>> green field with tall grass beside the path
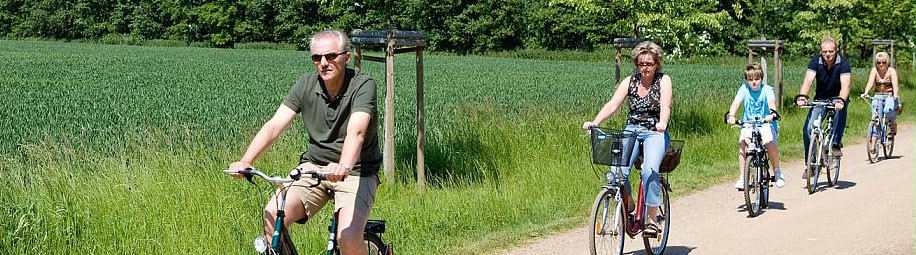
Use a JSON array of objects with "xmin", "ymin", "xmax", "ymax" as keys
[{"xmin": 0, "ymin": 41, "xmax": 916, "ymax": 254}]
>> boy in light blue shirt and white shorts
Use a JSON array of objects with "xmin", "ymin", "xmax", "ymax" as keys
[{"xmin": 727, "ymin": 63, "xmax": 786, "ymax": 189}]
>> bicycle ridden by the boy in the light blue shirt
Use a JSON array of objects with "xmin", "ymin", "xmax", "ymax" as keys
[{"xmin": 725, "ymin": 112, "xmax": 780, "ymax": 217}]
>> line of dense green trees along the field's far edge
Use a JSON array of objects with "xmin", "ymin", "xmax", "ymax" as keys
[{"xmin": 0, "ymin": 0, "xmax": 916, "ymax": 56}]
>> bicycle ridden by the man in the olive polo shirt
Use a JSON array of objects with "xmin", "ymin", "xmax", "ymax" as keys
[{"xmin": 223, "ymin": 168, "xmax": 393, "ymax": 255}]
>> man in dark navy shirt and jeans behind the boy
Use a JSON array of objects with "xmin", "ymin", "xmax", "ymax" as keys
[{"xmin": 795, "ymin": 37, "xmax": 852, "ymax": 177}]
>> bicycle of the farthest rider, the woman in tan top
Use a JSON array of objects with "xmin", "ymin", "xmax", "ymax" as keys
[{"xmin": 861, "ymin": 94, "xmax": 894, "ymax": 163}]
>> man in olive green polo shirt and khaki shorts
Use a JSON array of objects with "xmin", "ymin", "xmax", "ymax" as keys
[{"xmin": 229, "ymin": 30, "xmax": 382, "ymax": 255}]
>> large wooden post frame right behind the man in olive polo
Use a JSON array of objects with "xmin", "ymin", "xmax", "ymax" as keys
[{"xmin": 350, "ymin": 29, "xmax": 426, "ymax": 190}]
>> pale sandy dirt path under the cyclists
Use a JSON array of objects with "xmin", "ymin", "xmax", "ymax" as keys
[{"xmin": 503, "ymin": 124, "xmax": 916, "ymax": 255}]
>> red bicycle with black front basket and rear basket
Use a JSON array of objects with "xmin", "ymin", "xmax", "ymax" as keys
[{"xmin": 588, "ymin": 127, "xmax": 684, "ymax": 255}]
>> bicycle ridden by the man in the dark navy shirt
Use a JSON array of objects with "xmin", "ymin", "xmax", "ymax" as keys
[{"xmin": 800, "ymin": 100, "xmax": 840, "ymax": 194}]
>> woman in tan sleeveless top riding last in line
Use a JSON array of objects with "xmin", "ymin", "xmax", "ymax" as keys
[{"xmin": 859, "ymin": 51, "xmax": 900, "ymax": 135}]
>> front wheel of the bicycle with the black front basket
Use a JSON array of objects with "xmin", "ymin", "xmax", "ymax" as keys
[{"xmin": 588, "ymin": 188, "xmax": 626, "ymax": 255}]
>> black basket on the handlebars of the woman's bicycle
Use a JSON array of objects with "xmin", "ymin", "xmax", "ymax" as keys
[{"xmin": 591, "ymin": 128, "xmax": 636, "ymax": 167}]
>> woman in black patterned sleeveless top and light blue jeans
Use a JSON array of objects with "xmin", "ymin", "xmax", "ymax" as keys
[{"xmin": 582, "ymin": 41, "xmax": 672, "ymax": 234}]
